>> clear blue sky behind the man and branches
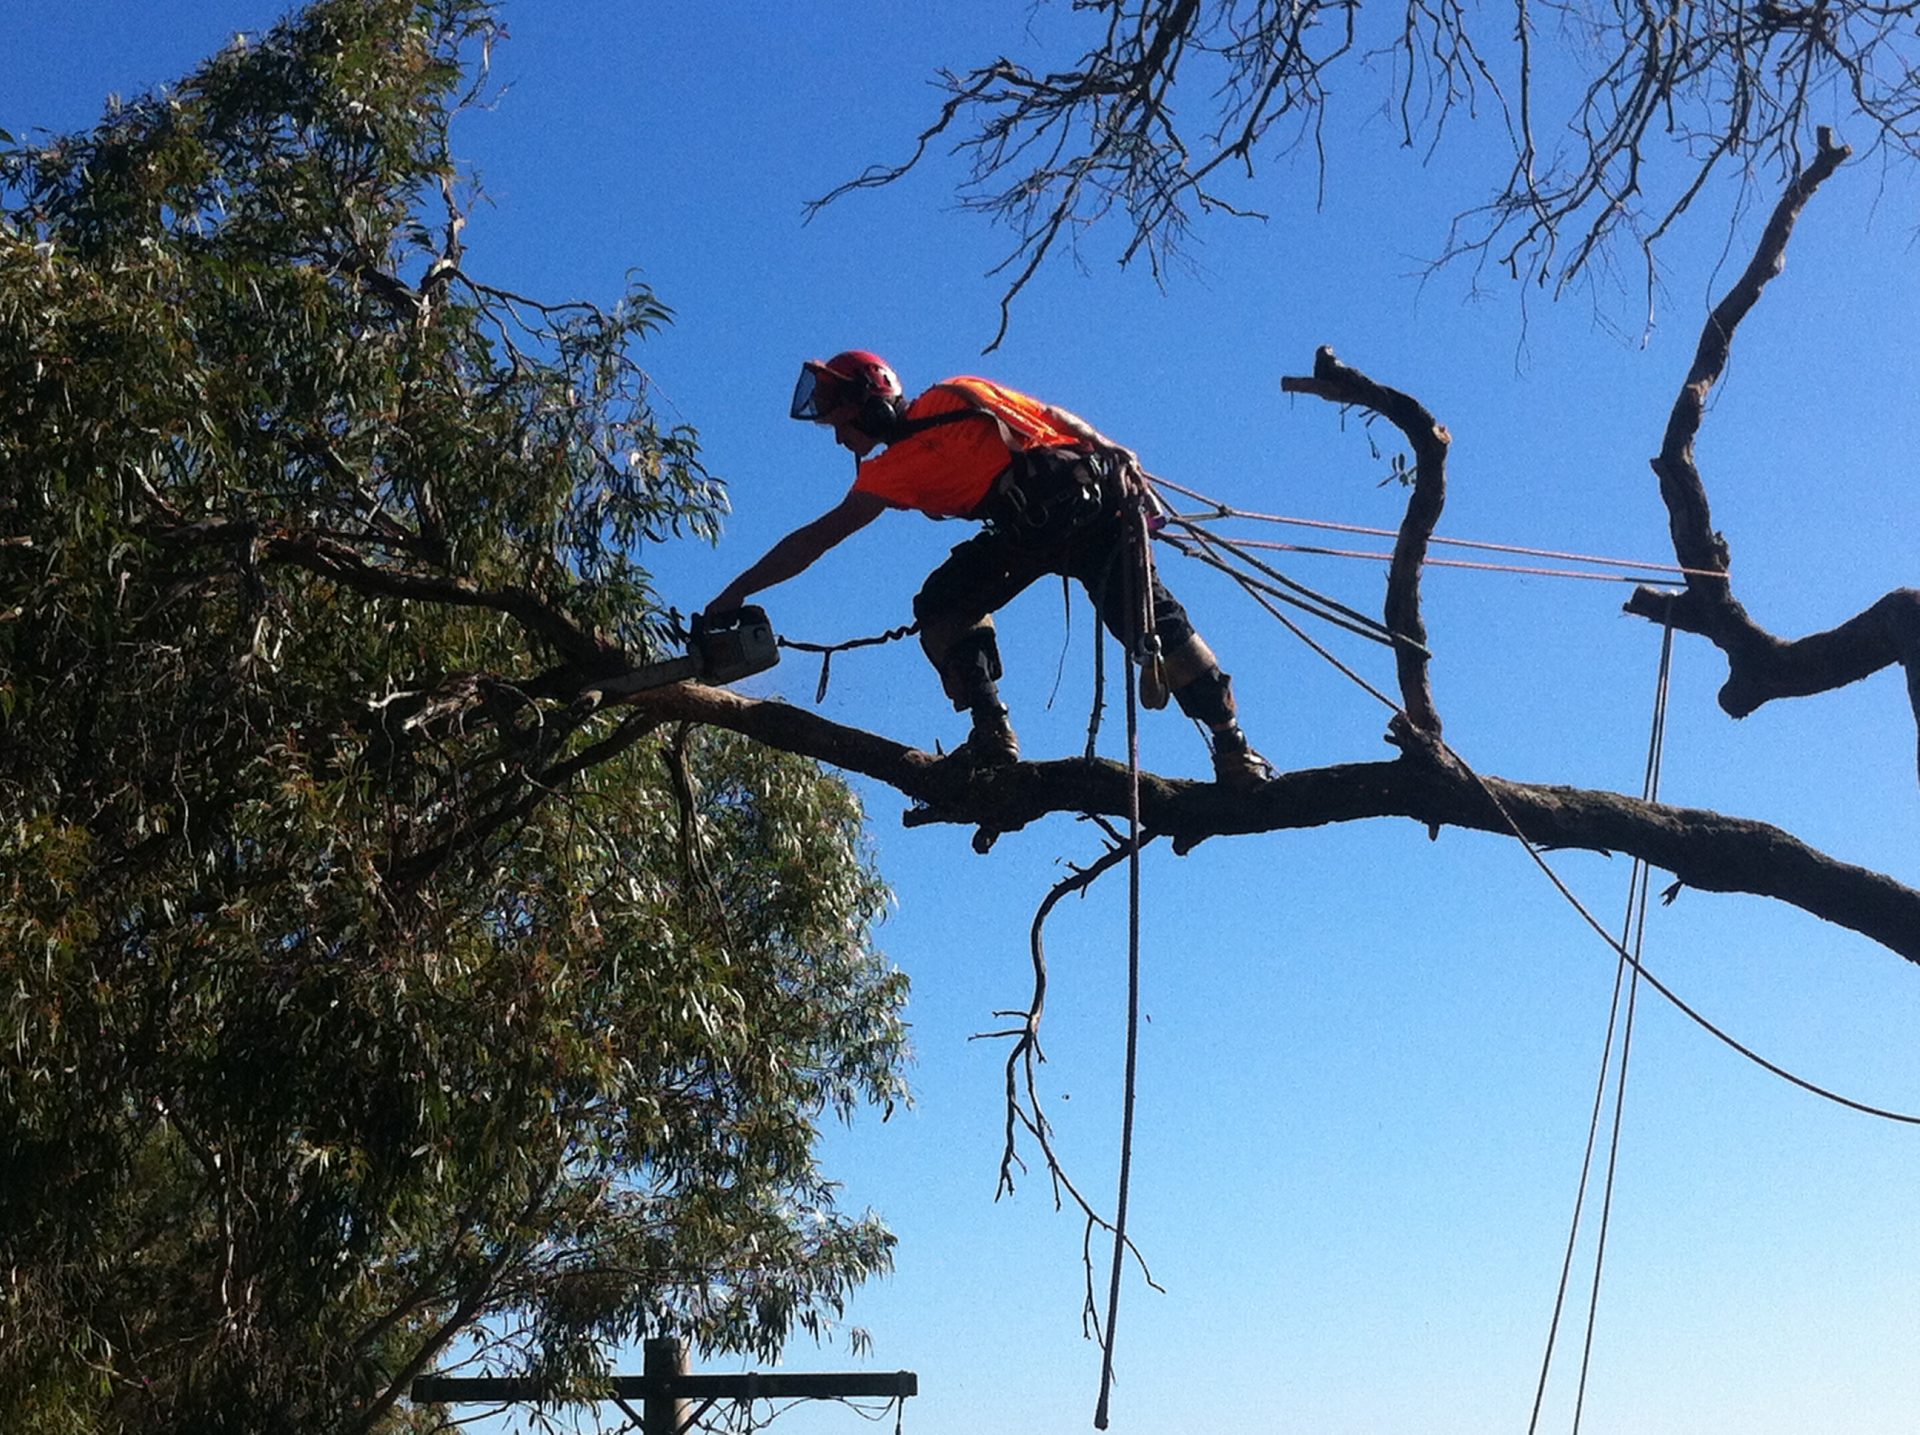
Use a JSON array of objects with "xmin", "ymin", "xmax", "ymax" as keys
[{"xmin": 0, "ymin": 0, "xmax": 1920, "ymax": 1435}]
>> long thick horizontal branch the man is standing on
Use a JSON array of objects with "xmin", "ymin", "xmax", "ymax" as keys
[{"xmin": 634, "ymin": 682, "xmax": 1920, "ymax": 962}]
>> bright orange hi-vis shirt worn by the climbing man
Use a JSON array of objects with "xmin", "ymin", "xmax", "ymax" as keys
[{"xmin": 852, "ymin": 375, "xmax": 1081, "ymax": 519}]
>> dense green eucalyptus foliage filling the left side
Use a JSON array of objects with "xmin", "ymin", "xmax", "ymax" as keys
[{"xmin": 0, "ymin": 0, "xmax": 904, "ymax": 1431}]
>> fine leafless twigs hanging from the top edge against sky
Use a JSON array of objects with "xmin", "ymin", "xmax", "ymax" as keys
[{"xmin": 837, "ymin": 0, "xmax": 1920, "ymax": 338}]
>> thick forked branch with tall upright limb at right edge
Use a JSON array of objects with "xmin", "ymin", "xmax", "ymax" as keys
[{"xmin": 1626, "ymin": 129, "xmax": 1920, "ymax": 779}]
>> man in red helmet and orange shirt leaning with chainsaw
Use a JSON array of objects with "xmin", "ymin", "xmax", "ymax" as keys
[{"xmin": 708, "ymin": 350, "xmax": 1273, "ymax": 790}]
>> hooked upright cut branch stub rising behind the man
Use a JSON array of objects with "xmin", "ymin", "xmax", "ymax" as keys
[{"xmin": 1281, "ymin": 344, "xmax": 1453, "ymax": 738}]
